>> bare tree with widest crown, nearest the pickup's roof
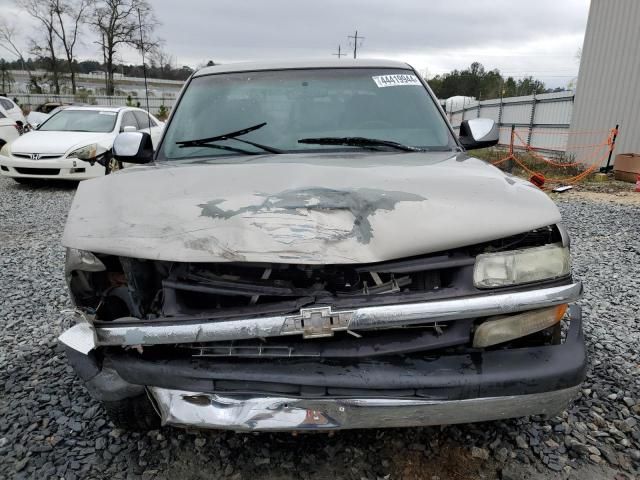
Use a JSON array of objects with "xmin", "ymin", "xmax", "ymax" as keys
[{"xmin": 91, "ymin": 0, "xmax": 158, "ymax": 95}]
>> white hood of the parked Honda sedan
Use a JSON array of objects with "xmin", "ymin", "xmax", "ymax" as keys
[{"xmin": 11, "ymin": 130, "xmax": 113, "ymax": 155}]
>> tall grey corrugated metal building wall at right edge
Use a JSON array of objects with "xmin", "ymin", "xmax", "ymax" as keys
[{"xmin": 571, "ymin": 0, "xmax": 640, "ymax": 163}]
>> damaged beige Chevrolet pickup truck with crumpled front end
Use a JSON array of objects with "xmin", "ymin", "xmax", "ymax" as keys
[{"xmin": 60, "ymin": 60, "xmax": 586, "ymax": 431}]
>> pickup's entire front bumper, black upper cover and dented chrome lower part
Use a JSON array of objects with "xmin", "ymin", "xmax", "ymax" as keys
[{"xmin": 61, "ymin": 305, "xmax": 586, "ymax": 431}]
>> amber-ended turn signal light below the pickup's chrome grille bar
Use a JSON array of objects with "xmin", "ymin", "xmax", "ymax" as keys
[{"xmin": 473, "ymin": 303, "xmax": 567, "ymax": 348}]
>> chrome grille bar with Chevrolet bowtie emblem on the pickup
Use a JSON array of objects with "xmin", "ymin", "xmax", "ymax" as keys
[{"xmin": 91, "ymin": 282, "xmax": 582, "ymax": 351}]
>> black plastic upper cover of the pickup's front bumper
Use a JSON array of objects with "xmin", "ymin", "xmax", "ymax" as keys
[{"xmin": 105, "ymin": 306, "xmax": 586, "ymax": 400}]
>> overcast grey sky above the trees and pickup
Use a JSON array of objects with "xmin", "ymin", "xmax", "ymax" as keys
[{"xmin": 0, "ymin": 0, "xmax": 589, "ymax": 87}]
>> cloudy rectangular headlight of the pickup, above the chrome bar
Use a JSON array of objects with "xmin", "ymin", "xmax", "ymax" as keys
[{"xmin": 473, "ymin": 243, "xmax": 571, "ymax": 288}]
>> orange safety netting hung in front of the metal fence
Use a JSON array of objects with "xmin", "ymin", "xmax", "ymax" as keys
[{"xmin": 492, "ymin": 128, "xmax": 618, "ymax": 183}]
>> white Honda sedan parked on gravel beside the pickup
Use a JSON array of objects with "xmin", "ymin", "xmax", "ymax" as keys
[{"xmin": 0, "ymin": 106, "xmax": 164, "ymax": 183}]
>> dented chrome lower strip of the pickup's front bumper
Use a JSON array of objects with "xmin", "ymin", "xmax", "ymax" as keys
[{"xmin": 149, "ymin": 386, "xmax": 579, "ymax": 431}]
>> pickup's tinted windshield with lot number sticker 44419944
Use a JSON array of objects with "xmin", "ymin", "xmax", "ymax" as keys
[{"xmin": 158, "ymin": 68, "xmax": 455, "ymax": 160}]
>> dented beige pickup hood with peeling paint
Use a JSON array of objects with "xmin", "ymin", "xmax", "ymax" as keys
[{"xmin": 63, "ymin": 152, "xmax": 560, "ymax": 264}]
